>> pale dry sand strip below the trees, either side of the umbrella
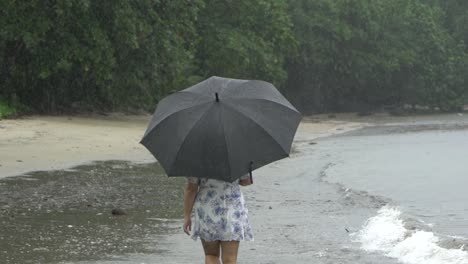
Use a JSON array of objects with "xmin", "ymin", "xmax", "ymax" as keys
[{"xmin": 0, "ymin": 114, "xmax": 361, "ymax": 178}]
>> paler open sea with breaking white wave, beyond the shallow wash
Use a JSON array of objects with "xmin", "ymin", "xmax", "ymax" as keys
[{"xmin": 316, "ymin": 124, "xmax": 468, "ymax": 264}]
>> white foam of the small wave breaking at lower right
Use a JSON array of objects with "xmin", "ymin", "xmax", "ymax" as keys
[{"xmin": 352, "ymin": 206, "xmax": 468, "ymax": 264}]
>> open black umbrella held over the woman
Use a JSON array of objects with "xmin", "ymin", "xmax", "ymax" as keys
[{"xmin": 141, "ymin": 76, "xmax": 301, "ymax": 182}]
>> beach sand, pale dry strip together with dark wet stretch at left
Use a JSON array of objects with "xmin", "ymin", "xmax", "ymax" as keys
[{"xmin": 0, "ymin": 115, "xmax": 361, "ymax": 263}]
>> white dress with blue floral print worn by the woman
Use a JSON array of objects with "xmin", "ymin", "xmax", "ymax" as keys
[{"xmin": 188, "ymin": 177, "xmax": 254, "ymax": 241}]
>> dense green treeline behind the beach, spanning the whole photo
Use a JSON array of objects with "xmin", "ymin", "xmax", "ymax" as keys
[{"xmin": 0, "ymin": 0, "xmax": 468, "ymax": 113}]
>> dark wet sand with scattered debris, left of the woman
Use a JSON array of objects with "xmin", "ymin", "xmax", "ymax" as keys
[{"xmin": 0, "ymin": 161, "xmax": 184, "ymax": 264}]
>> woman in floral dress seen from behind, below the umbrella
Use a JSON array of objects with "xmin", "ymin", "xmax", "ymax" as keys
[{"xmin": 184, "ymin": 175, "xmax": 253, "ymax": 264}]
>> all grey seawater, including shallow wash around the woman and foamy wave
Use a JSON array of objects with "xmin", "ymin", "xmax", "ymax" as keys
[{"xmin": 74, "ymin": 121, "xmax": 468, "ymax": 264}]
